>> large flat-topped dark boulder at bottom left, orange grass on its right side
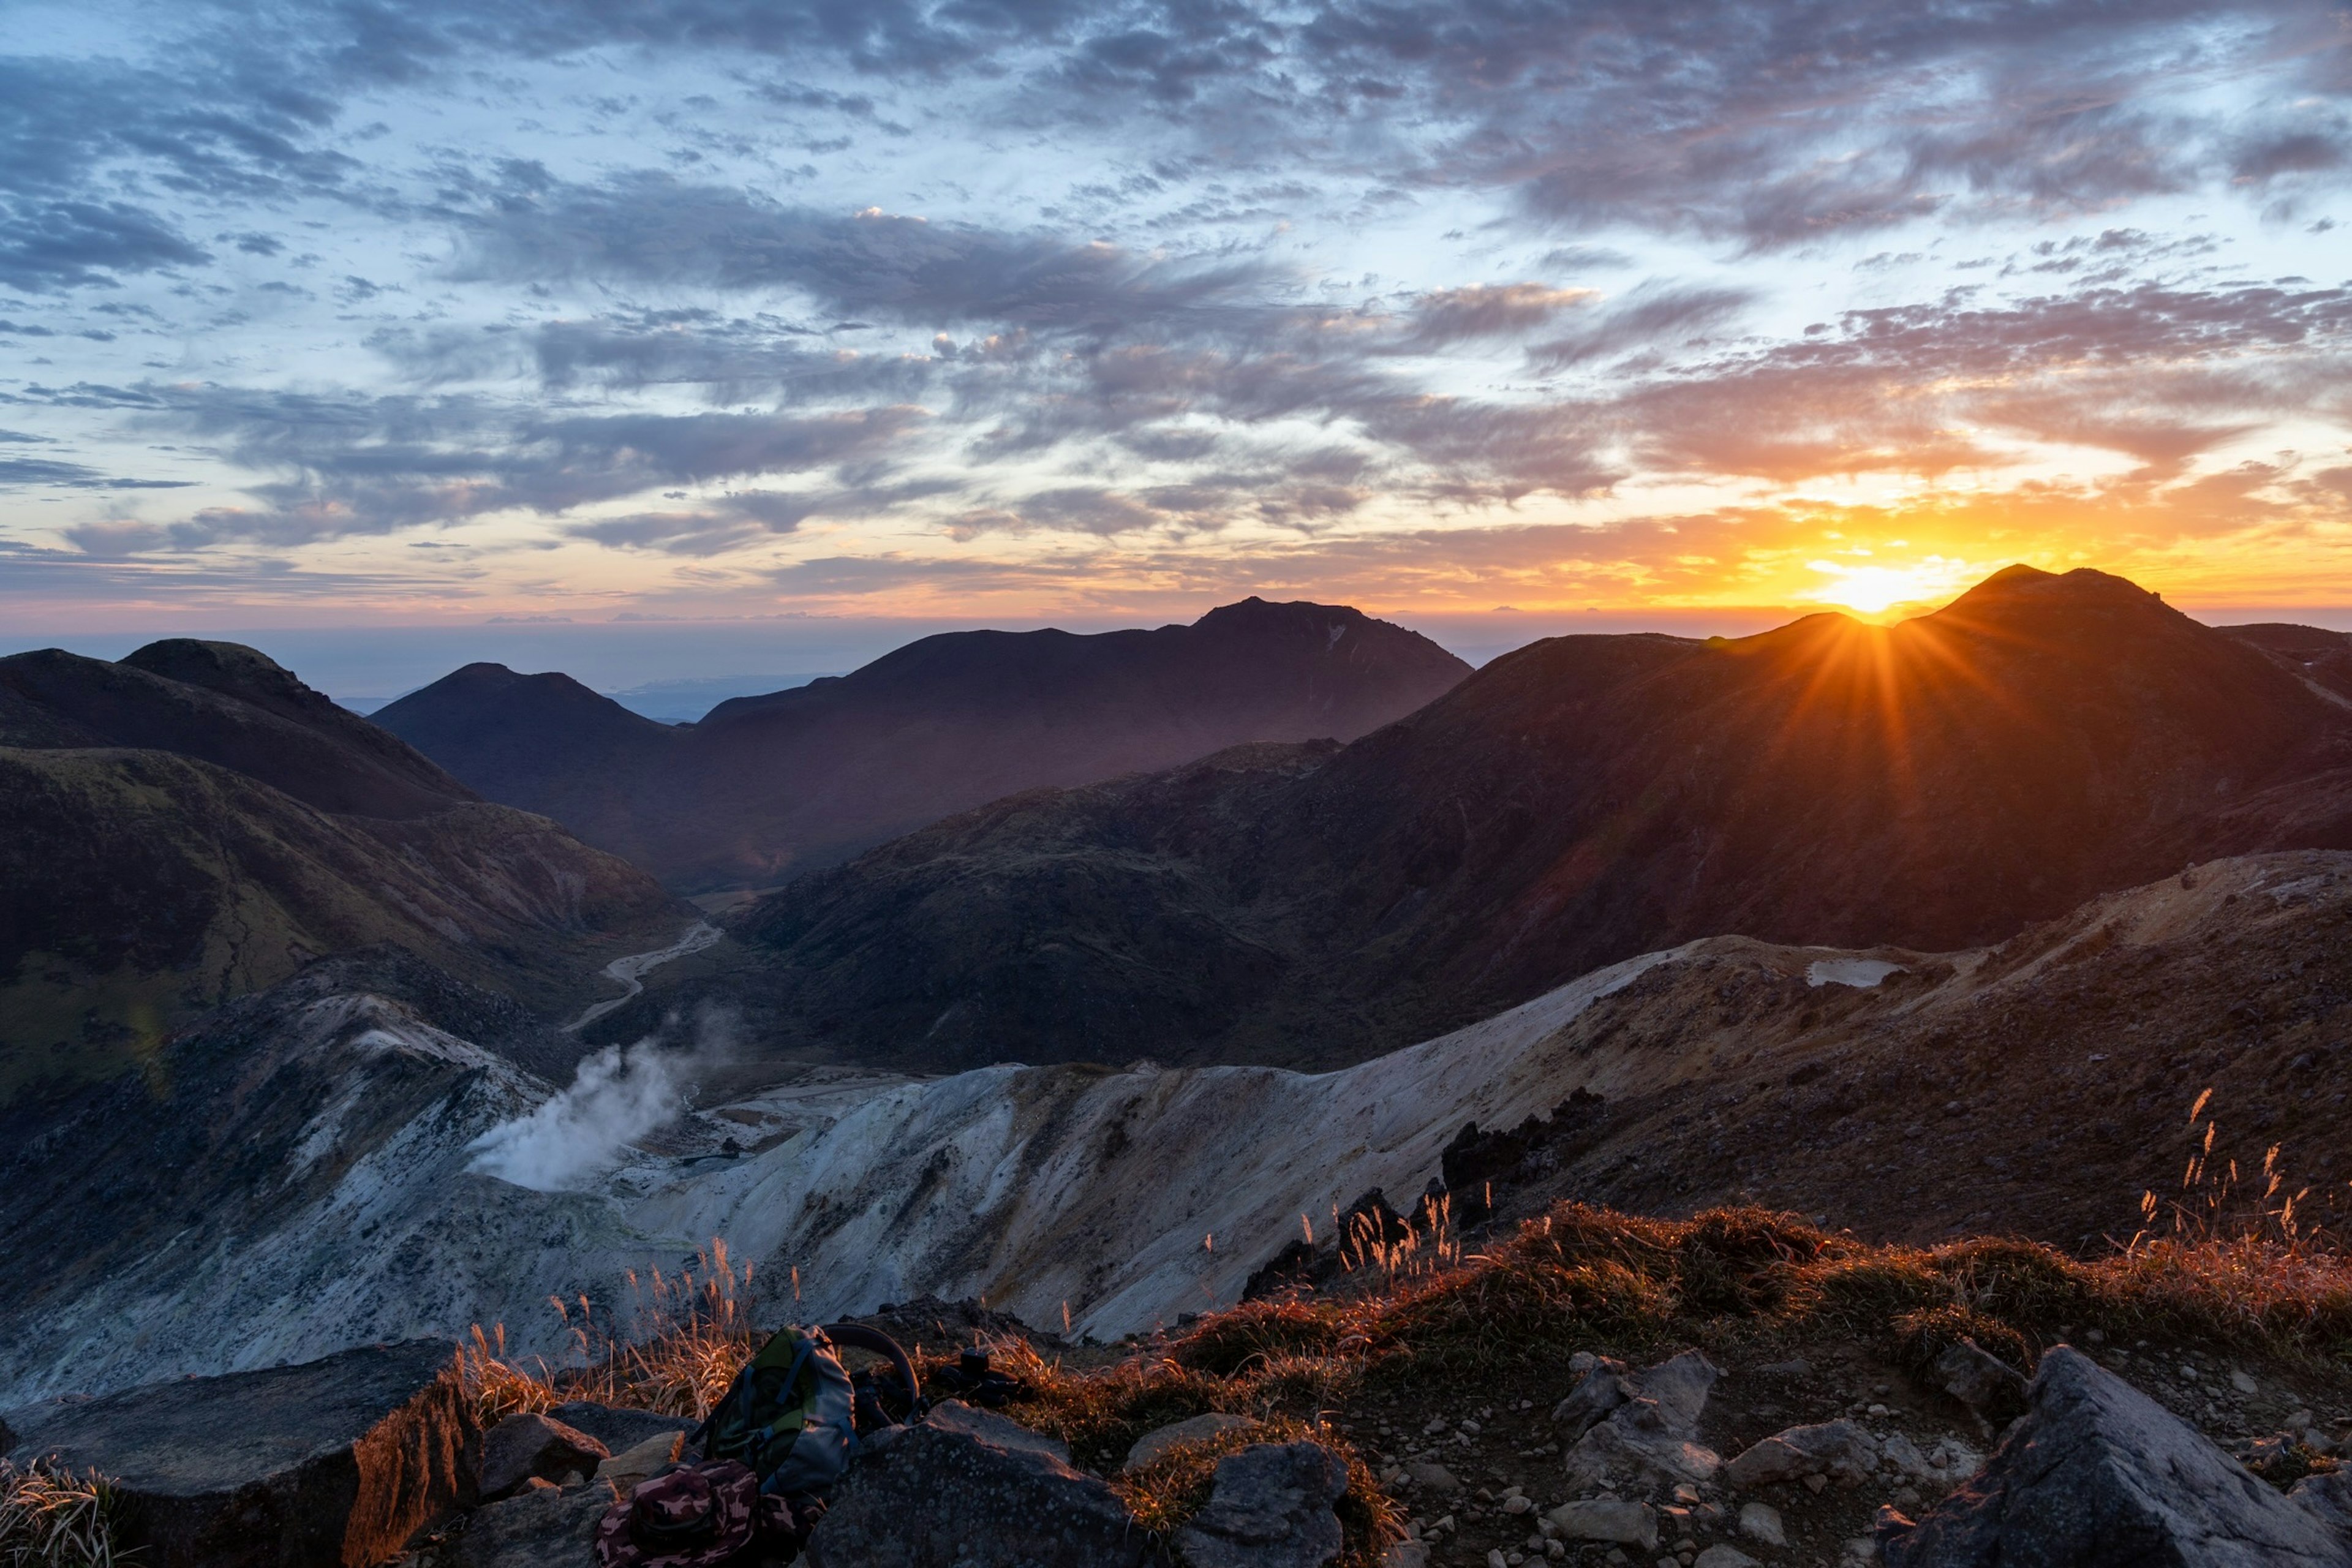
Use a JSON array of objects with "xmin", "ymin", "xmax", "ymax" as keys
[{"xmin": 12, "ymin": 1340, "xmax": 478, "ymax": 1568}]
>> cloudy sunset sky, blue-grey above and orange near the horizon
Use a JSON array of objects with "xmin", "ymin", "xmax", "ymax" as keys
[{"xmin": 0, "ymin": 0, "xmax": 2352, "ymax": 635}]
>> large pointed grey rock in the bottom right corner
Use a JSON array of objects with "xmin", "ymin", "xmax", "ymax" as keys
[{"xmin": 1882, "ymin": 1344, "xmax": 2352, "ymax": 1568}]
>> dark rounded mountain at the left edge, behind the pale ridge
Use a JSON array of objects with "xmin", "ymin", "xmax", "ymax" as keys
[{"xmin": 0, "ymin": 639, "xmax": 684, "ymax": 1098}]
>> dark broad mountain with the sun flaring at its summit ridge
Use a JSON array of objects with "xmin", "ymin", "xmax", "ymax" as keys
[{"xmin": 649, "ymin": 567, "xmax": 2352, "ymax": 1069}]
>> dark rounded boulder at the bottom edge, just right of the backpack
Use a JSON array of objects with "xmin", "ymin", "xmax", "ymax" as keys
[{"xmin": 807, "ymin": 1399, "xmax": 1150, "ymax": 1568}]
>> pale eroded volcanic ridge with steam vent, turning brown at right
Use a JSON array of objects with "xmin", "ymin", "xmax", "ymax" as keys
[{"xmin": 0, "ymin": 853, "xmax": 2352, "ymax": 1411}]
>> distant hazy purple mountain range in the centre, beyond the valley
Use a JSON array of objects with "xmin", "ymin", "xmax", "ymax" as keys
[{"xmin": 374, "ymin": 600, "xmax": 1470, "ymax": 891}]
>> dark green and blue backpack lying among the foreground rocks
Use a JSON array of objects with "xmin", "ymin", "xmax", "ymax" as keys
[{"xmin": 689, "ymin": 1324, "xmax": 919, "ymax": 1498}]
